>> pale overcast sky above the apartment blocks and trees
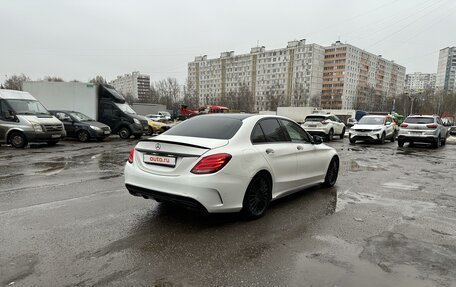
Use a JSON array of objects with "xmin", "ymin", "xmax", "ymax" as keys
[{"xmin": 0, "ymin": 0, "xmax": 456, "ymax": 84}]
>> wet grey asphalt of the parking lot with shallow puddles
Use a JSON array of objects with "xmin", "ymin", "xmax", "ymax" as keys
[{"xmin": 0, "ymin": 138, "xmax": 456, "ymax": 286}]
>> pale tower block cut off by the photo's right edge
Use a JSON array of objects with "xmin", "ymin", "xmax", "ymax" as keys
[{"xmin": 435, "ymin": 47, "xmax": 456, "ymax": 92}]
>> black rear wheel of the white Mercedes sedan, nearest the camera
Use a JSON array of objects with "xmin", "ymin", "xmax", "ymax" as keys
[{"xmin": 242, "ymin": 174, "xmax": 272, "ymax": 219}]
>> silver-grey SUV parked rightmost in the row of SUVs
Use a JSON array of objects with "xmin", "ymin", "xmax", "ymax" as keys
[{"xmin": 397, "ymin": 115, "xmax": 448, "ymax": 148}]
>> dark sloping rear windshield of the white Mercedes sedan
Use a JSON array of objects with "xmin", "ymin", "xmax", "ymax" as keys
[{"xmin": 164, "ymin": 116, "xmax": 242, "ymax": 140}]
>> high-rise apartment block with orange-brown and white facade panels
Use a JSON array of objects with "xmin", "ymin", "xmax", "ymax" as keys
[{"xmin": 321, "ymin": 41, "xmax": 405, "ymax": 109}]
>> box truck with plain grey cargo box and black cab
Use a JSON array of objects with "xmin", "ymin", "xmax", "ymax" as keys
[{"xmin": 23, "ymin": 81, "xmax": 149, "ymax": 139}]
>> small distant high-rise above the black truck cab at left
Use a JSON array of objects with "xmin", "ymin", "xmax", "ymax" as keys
[{"xmin": 109, "ymin": 72, "xmax": 150, "ymax": 100}]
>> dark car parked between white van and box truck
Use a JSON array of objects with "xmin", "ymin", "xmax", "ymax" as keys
[{"xmin": 49, "ymin": 110, "xmax": 111, "ymax": 142}]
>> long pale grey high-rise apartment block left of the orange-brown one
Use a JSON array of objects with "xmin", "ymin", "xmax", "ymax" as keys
[{"xmin": 188, "ymin": 40, "xmax": 325, "ymax": 111}]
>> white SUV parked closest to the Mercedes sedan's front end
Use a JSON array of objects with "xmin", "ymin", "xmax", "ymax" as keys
[{"xmin": 302, "ymin": 114, "xmax": 345, "ymax": 141}]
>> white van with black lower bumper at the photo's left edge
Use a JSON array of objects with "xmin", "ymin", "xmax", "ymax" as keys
[{"xmin": 0, "ymin": 89, "xmax": 66, "ymax": 148}]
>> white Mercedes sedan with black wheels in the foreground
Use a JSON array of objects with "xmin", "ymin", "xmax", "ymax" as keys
[{"xmin": 125, "ymin": 114, "xmax": 339, "ymax": 218}]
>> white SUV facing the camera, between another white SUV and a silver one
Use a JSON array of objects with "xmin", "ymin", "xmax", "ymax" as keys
[{"xmin": 348, "ymin": 115, "xmax": 397, "ymax": 144}]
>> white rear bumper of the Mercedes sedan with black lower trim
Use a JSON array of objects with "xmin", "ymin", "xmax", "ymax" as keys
[{"xmin": 125, "ymin": 162, "xmax": 250, "ymax": 213}]
